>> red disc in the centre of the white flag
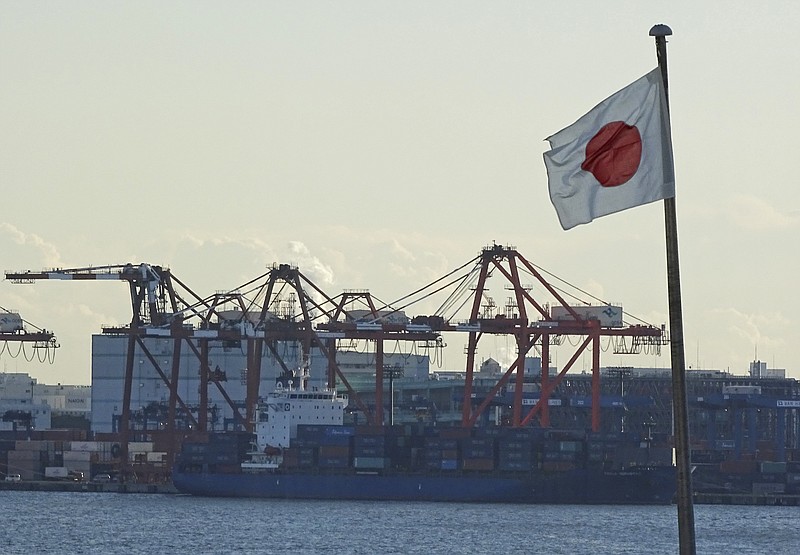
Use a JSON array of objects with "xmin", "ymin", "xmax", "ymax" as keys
[{"xmin": 581, "ymin": 121, "xmax": 642, "ymax": 187}]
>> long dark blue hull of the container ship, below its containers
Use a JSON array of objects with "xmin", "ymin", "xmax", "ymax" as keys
[{"xmin": 173, "ymin": 467, "xmax": 675, "ymax": 504}]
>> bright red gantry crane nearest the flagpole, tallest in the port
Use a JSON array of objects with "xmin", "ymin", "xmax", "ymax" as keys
[{"xmin": 340, "ymin": 245, "xmax": 668, "ymax": 431}]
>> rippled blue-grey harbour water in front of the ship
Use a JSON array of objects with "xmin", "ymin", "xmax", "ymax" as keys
[{"xmin": 0, "ymin": 492, "xmax": 800, "ymax": 555}]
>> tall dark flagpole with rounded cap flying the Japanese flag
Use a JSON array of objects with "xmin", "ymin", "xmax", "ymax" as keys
[{"xmin": 650, "ymin": 25, "xmax": 696, "ymax": 555}]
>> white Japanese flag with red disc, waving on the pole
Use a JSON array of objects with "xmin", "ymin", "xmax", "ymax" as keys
[{"xmin": 544, "ymin": 68, "xmax": 675, "ymax": 229}]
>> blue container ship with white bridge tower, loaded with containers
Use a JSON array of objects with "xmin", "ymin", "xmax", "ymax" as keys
[{"xmin": 172, "ymin": 387, "xmax": 676, "ymax": 504}]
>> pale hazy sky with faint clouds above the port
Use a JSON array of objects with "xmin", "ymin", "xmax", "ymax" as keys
[{"xmin": 0, "ymin": 0, "xmax": 800, "ymax": 384}]
